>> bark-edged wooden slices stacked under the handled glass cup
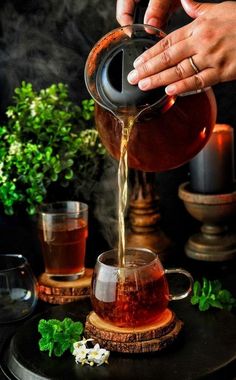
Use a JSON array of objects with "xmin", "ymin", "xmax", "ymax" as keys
[{"xmin": 85, "ymin": 309, "xmax": 183, "ymax": 353}]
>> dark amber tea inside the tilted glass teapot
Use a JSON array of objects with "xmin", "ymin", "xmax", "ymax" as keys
[{"xmin": 95, "ymin": 89, "xmax": 216, "ymax": 172}]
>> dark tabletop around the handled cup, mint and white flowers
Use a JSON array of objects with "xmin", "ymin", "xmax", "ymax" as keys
[{"xmin": 0, "ymin": 259, "xmax": 236, "ymax": 380}]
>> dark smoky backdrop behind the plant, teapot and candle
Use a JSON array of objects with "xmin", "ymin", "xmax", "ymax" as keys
[{"xmin": 0, "ymin": 0, "xmax": 236, "ymax": 271}]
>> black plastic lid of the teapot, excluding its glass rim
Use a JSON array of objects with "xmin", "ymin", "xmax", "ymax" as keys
[{"xmin": 96, "ymin": 31, "xmax": 165, "ymax": 108}]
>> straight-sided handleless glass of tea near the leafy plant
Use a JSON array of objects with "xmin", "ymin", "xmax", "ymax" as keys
[{"xmin": 39, "ymin": 201, "xmax": 88, "ymax": 279}]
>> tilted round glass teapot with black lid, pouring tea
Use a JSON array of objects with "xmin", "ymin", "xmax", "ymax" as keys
[{"xmin": 85, "ymin": 2, "xmax": 216, "ymax": 172}]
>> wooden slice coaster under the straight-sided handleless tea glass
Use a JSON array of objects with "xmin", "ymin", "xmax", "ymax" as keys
[{"xmin": 38, "ymin": 268, "xmax": 93, "ymax": 304}]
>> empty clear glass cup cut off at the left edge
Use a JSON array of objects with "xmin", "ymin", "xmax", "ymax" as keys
[{"xmin": 0, "ymin": 254, "xmax": 38, "ymax": 323}]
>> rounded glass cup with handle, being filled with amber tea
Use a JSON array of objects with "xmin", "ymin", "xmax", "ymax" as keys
[{"xmin": 91, "ymin": 248, "xmax": 193, "ymax": 328}]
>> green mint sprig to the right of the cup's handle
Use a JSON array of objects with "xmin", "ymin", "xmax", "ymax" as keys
[{"xmin": 191, "ymin": 277, "xmax": 236, "ymax": 311}]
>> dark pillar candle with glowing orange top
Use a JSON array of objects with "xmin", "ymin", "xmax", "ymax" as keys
[{"xmin": 190, "ymin": 124, "xmax": 234, "ymax": 194}]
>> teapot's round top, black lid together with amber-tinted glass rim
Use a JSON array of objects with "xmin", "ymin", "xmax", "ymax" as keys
[{"xmin": 85, "ymin": 24, "xmax": 166, "ymax": 111}]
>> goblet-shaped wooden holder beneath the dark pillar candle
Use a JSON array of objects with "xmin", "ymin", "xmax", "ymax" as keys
[{"xmin": 179, "ymin": 182, "xmax": 236, "ymax": 262}]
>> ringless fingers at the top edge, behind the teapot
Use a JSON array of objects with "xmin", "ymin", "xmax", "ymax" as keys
[{"xmin": 116, "ymin": 0, "xmax": 180, "ymax": 28}]
